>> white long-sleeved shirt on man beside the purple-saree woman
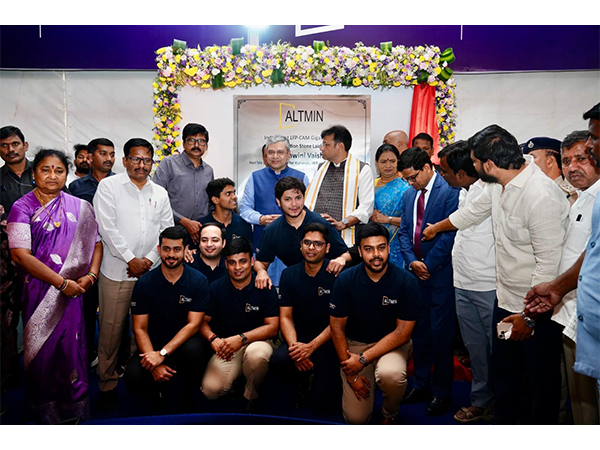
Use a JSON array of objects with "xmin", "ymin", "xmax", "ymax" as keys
[{"xmin": 94, "ymin": 173, "xmax": 173, "ymax": 281}]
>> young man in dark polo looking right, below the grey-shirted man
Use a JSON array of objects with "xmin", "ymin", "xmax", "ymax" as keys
[{"xmin": 200, "ymin": 178, "xmax": 252, "ymax": 246}]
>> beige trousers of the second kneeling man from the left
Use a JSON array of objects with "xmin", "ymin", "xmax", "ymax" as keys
[{"xmin": 201, "ymin": 341, "xmax": 273, "ymax": 400}]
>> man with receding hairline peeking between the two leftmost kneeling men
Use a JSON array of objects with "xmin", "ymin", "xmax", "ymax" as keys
[{"xmin": 190, "ymin": 222, "xmax": 227, "ymax": 284}]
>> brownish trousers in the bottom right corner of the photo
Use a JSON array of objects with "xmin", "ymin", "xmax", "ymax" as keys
[{"xmin": 563, "ymin": 336, "xmax": 598, "ymax": 425}]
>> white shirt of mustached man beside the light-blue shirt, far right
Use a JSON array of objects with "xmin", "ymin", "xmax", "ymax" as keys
[{"xmin": 552, "ymin": 176, "xmax": 600, "ymax": 341}]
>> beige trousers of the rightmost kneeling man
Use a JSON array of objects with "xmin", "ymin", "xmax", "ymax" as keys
[{"xmin": 340, "ymin": 339, "xmax": 412, "ymax": 425}]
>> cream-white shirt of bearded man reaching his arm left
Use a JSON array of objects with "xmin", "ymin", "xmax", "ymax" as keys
[{"xmin": 449, "ymin": 155, "xmax": 569, "ymax": 313}]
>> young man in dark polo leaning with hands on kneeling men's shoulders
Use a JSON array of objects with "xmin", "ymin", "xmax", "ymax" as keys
[{"xmin": 254, "ymin": 177, "xmax": 351, "ymax": 289}]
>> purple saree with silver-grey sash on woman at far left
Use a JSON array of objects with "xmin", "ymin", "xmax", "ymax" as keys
[{"xmin": 7, "ymin": 192, "xmax": 98, "ymax": 424}]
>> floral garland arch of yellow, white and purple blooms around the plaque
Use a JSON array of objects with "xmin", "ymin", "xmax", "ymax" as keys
[{"xmin": 152, "ymin": 38, "xmax": 456, "ymax": 161}]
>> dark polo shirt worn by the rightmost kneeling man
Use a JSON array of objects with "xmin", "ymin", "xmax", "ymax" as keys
[{"xmin": 329, "ymin": 263, "xmax": 419, "ymax": 344}]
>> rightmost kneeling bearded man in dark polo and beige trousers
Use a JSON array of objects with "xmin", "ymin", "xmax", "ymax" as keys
[{"xmin": 330, "ymin": 222, "xmax": 419, "ymax": 424}]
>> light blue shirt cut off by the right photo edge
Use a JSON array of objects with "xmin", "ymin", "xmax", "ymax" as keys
[{"xmin": 575, "ymin": 195, "xmax": 600, "ymax": 379}]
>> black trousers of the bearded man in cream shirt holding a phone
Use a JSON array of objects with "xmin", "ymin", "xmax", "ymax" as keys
[{"xmin": 492, "ymin": 306, "xmax": 562, "ymax": 425}]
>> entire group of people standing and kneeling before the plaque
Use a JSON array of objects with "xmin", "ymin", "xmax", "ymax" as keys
[{"xmin": 0, "ymin": 104, "xmax": 600, "ymax": 424}]
